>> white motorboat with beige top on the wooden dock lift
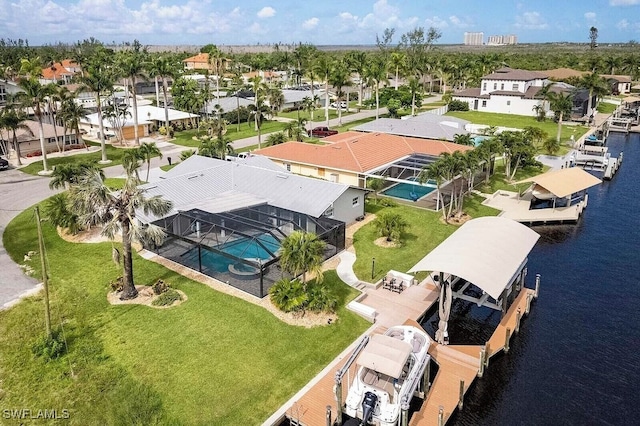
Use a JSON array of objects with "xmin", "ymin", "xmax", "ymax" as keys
[{"xmin": 345, "ymin": 325, "xmax": 431, "ymax": 426}]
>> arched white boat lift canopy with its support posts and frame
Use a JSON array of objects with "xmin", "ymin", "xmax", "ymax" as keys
[{"xmin": 408, "ymin": 217, "xmax": 540, "ymax": 343}]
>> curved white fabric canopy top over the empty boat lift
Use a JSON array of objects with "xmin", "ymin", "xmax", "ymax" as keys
[{"xmin": 408, "ymin": 217, "xmax": 540, "ymax": 300}]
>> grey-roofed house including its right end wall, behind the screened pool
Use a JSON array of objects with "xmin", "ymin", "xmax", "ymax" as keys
[{"xmin": 143, "ymin": 155, "xmax": 367, "ymax": 223}]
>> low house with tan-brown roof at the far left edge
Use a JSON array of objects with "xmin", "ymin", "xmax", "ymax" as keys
[{"xmin": 0, "ymin": 120, "xmax": 76, "ymax": 157}]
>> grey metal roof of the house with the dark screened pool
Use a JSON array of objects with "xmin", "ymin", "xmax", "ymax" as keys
[{"xmin": 143, "ymin": 155, "xmax": 350, "ymax": 217}]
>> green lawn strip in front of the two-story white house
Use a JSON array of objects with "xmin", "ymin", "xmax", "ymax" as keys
[{"xmin": 447, "ymin": 111, "xmax": 589, "ymax": 143}]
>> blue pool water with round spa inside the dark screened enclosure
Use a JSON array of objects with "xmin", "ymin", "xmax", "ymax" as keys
[{"xmin": 183, "ymin": 234, "xmax": 280, "ymax": 272}]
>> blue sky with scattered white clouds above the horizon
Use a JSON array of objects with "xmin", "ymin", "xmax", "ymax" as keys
[{"xmin": 0, "ymin": 0, "xmax": 640, "ymax": 45}]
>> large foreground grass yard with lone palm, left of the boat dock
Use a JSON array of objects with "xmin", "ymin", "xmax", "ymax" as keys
[{"xmin": 0, "ymin": 202, "xmax": 370, "ymax": 425}]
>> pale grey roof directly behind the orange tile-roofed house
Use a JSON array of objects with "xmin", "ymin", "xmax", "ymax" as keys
[{"xmin": 351, "ymin": 113, "xmax": 470, "ymax": 141}]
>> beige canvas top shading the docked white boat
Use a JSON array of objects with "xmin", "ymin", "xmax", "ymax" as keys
[{"xmin": 357, "ymin": 334, "xmax": 411, "ymax": 378}]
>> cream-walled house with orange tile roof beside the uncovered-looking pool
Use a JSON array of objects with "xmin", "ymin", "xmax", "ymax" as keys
[{"xmin": 253, "ymin": 132, "xmax": 473, "ymax": 188}]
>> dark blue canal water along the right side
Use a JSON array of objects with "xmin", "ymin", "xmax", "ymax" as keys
[{"xmin": 444, "ymin": 133, "xmax": 640, "ymax": 426}]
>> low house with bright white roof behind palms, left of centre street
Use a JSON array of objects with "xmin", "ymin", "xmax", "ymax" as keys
[{"xmin": 80, "ymin": 105, "xmax": 199, "ymax": 139}]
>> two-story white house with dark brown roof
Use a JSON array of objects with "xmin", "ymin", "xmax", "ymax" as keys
[{"xmin": 453, "ymin": 68, "xmax": 551, "ymax": 116}]
